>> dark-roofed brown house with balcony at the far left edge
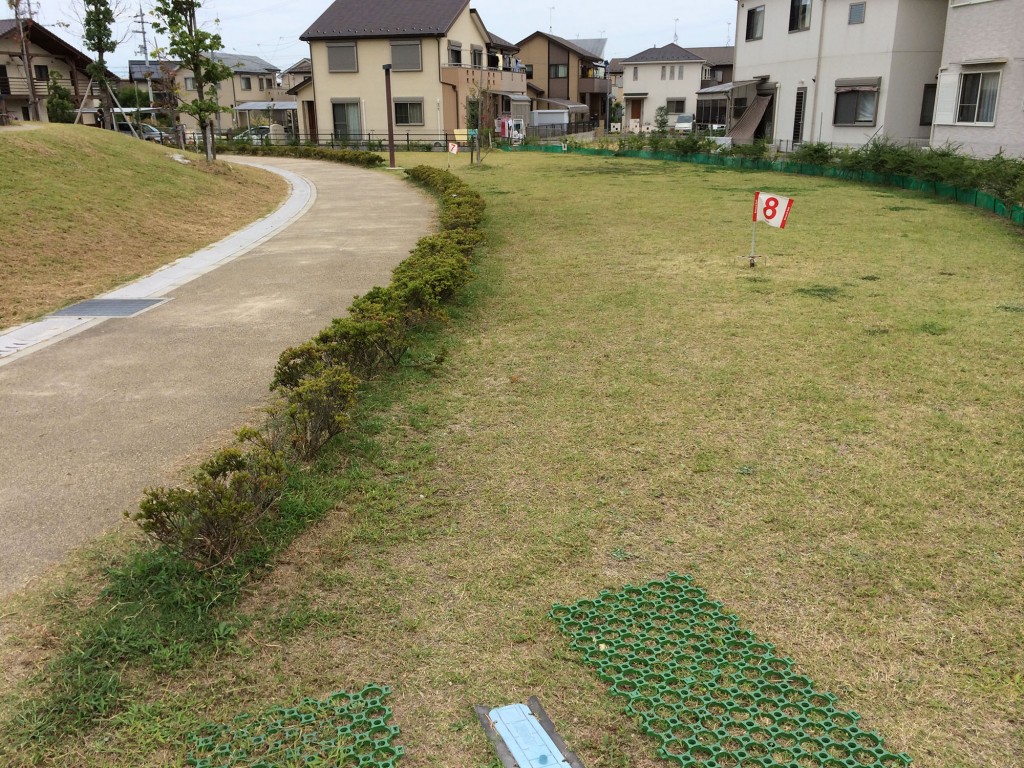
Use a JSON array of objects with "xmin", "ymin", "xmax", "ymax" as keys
[{"xmin": 0, "ymin": 18, "xmax": 112, "ymax": 125}]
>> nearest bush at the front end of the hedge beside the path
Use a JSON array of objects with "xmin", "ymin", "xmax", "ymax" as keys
[{"xmin": 126, "ymin": 447, "xmax": 287, "ymax": 569}]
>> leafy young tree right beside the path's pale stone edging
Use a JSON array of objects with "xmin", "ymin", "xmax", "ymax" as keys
[{"xmin": 153, "ymin": 0, "xmax": 232, "ymax": 162}]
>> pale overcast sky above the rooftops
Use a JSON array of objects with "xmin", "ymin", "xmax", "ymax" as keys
[{"xmin": 32, "ymin": 0, "xmax": 736, "ymax": 77}]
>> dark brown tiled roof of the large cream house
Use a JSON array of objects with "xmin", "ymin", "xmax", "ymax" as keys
[{"xmin": 299, "ymin": 0, "xmax": 469, "ymax": 40}]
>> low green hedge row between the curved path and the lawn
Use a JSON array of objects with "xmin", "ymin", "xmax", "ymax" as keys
[{"xmin": 130, "ymin": 163, "xmax": 484, "ymax": 570}]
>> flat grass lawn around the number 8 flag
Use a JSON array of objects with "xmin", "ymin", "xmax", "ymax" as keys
[{"xmin": 0, "ymin": 147, "xmax": 1024, "ymax": 768}]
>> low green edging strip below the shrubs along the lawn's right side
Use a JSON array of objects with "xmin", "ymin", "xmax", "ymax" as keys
[{"xmin": 505, "ymin": 144, "xmax": 1024, "ymax": 225}]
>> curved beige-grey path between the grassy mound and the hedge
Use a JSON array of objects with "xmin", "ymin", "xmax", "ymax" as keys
[{"xmin": 0, "ymin": 159, "xmax": 435, "ymax": 596}]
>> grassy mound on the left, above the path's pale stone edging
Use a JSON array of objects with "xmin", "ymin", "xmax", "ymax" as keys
[{"xmin": 0, "ymin": 125, "xmax": 286, "ymax": 329}]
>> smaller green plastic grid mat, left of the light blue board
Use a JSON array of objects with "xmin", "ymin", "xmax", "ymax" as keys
[{"xmin": 185, "ymin": 685, "xmax": 406, "ymax": 768}]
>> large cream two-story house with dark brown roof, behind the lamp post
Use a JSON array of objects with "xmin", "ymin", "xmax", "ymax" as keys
[{"xmin": 292, "ymin": 0, "xmax": 526, "ymax": 141}]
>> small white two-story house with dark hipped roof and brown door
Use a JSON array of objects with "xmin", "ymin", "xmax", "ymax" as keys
[{"xmin": 623, "ymin": 43, "xmax": 707, "ymax": 133}]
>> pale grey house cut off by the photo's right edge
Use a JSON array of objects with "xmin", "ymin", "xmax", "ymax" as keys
[{"xmin": 932, "ymin": 0, "xmax": 1024, "ymax": 157}]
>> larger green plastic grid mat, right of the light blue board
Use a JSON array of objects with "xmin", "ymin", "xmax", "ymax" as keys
[{"xmin": 550, "ymin": 573, "xmax": 910, "ymax": 768}]
